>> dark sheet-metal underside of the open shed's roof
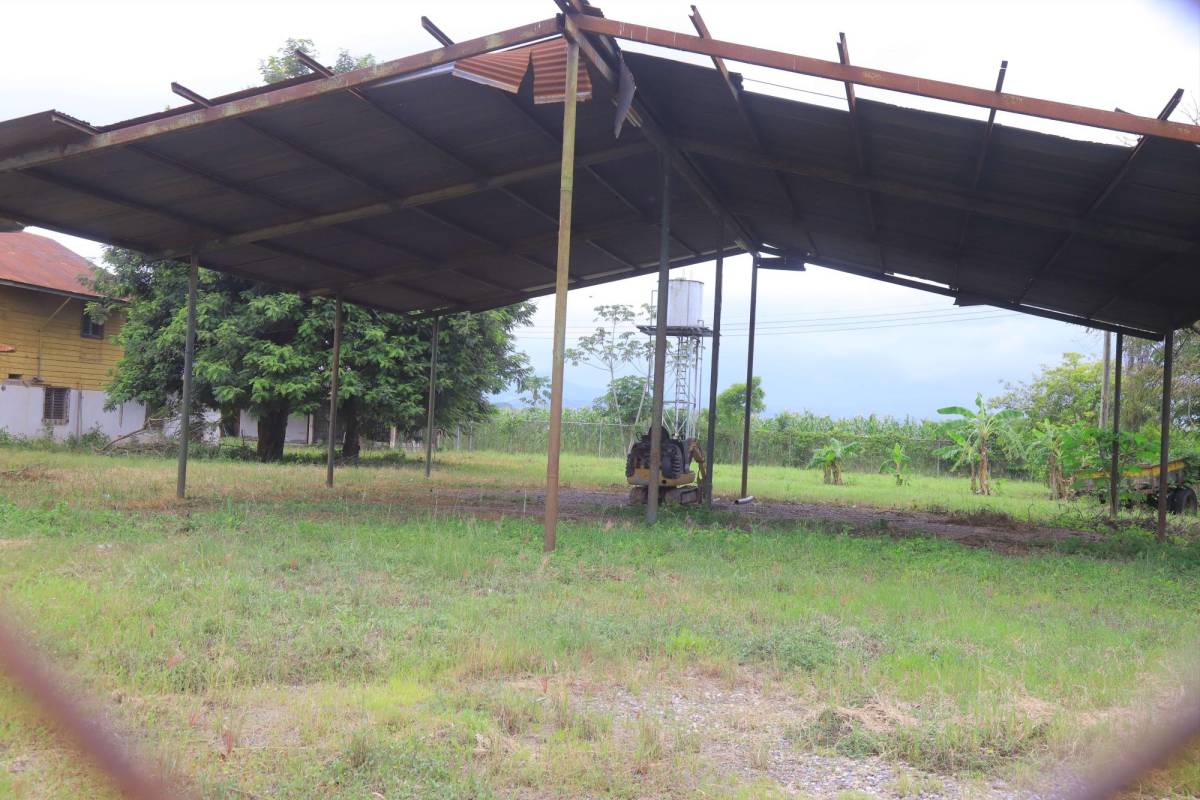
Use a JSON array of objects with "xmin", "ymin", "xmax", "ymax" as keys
[{"xmin": 0, "ymin": 38, "xmax": 1200, "ymax": 337}]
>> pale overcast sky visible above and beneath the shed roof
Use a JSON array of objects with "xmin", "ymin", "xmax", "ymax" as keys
[{"xmin": 0, "ymin": 0, "xmax": 1200, "ymax": 416}]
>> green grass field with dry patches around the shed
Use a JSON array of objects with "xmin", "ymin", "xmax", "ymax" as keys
[{"xmin": 0, "ymin": 449, "xmax": 1200, "ymax": 800}]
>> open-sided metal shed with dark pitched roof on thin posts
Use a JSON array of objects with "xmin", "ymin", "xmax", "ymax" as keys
[{"xmin": 0, "ymin": 0, "xmax": 1200, "ymax": 547}]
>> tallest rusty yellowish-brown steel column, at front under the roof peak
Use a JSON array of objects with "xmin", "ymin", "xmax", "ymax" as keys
[{"xmin": 542, "ymin": 41, "xmax": 580, "ymax": 553}]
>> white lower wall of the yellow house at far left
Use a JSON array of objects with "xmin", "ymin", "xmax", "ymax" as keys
[{"xmin": 0, "ymin": 380, "xmax": 146, "ymax": 441}]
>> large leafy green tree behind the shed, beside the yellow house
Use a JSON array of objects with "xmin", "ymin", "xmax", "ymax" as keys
[{"xmin": 88, "ymin": 40, "xmax": 532, "ymax": 461}]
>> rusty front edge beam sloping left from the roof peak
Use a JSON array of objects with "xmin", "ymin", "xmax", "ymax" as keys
[{"xmin": 0, "ymin": 18, "xmax": 562, "ymax": 173}]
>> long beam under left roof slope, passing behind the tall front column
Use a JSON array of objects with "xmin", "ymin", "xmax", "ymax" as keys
[{"xmin": 157, "ymin": 143, "xmax": 653, "ymax": 259}]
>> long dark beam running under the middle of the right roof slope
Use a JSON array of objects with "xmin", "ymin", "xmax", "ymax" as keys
[{"xmin": 679, "ymin": 139, "xmax": 1200, "ymax": 253}]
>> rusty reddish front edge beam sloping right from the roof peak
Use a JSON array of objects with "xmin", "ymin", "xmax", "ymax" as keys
[{"xmin": 566, "ymin": 14, "xmax": 1200, "ymax": 144}]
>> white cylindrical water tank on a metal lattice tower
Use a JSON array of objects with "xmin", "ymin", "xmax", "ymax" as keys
[{"xmin": 637, "ymin": 278, "xmax": 713, "ymax": 439}]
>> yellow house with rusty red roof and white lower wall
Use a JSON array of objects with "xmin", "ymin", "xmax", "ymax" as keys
[{"xmin": 0, "ymin": 231, "xmax": 145, "ymax": 439}]
